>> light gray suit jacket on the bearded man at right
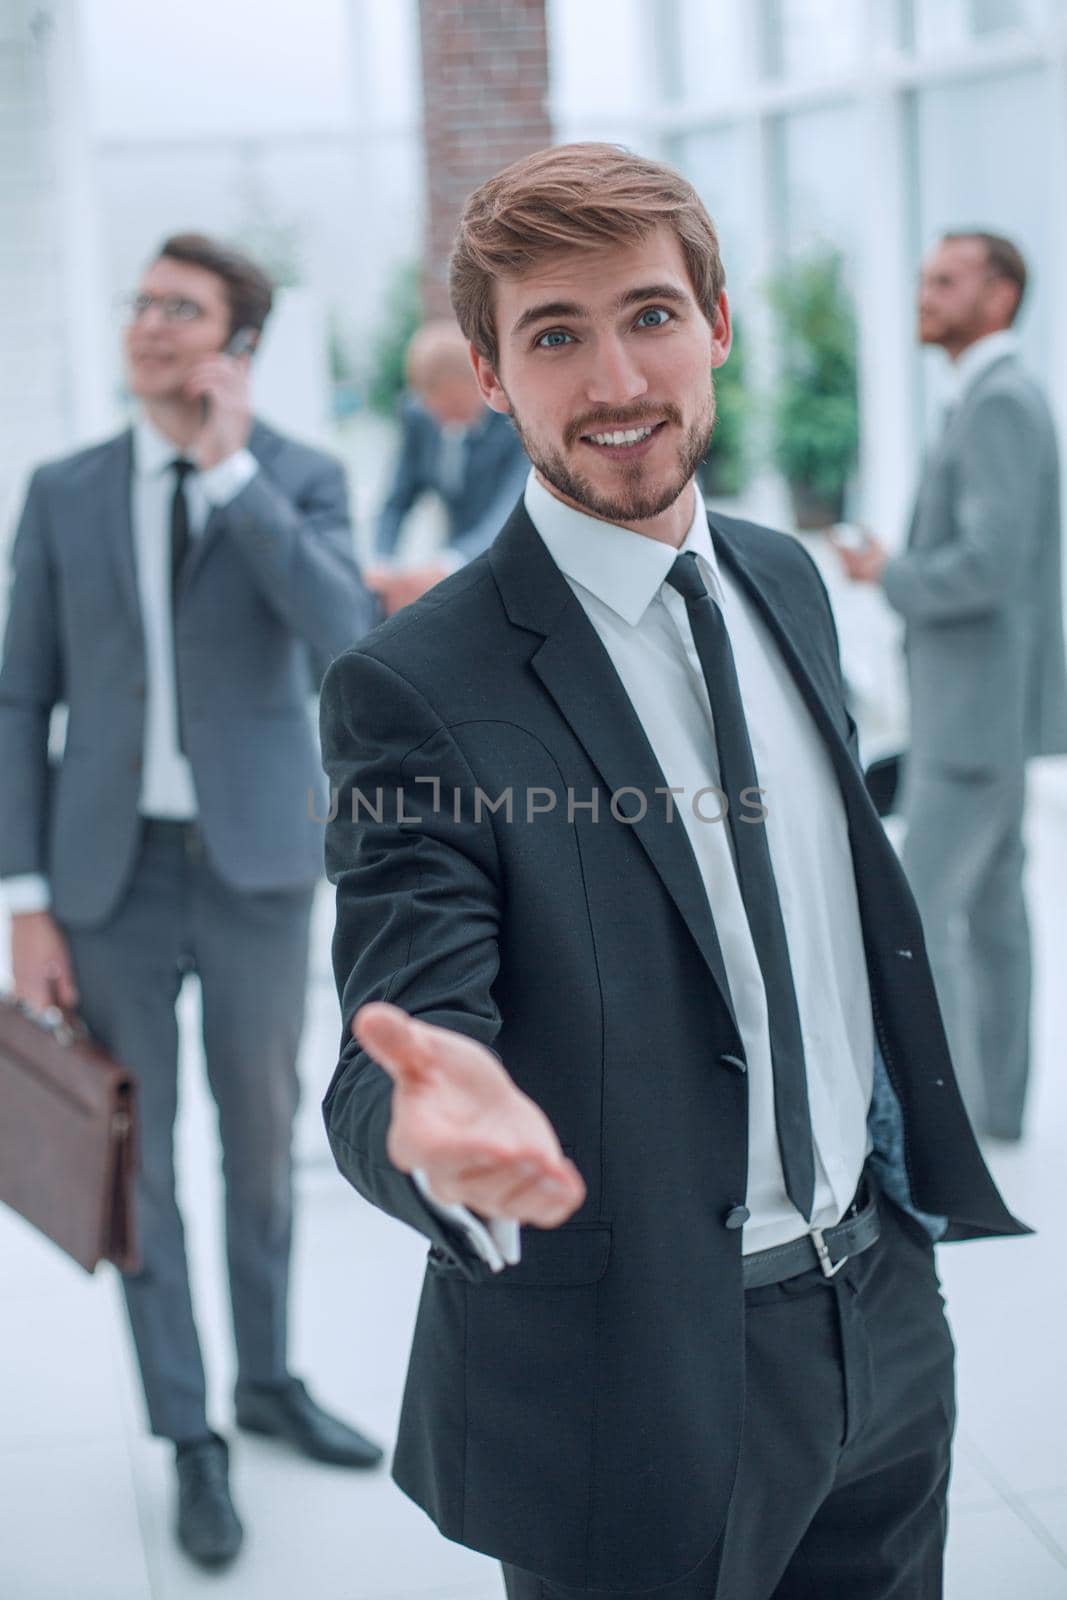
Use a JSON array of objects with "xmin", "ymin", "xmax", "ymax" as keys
[{"xmin": 883, "ymin": 355, "xmax": 1067, "ymax": 771}]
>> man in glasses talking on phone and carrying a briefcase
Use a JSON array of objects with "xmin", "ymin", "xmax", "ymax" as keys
[{"xmin": 0, "ymin": 234, "xmax": 381, "ymax": 1566}]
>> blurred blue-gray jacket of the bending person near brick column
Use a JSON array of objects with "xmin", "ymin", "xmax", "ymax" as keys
[{"xmin": 378, "ymin": 395, "xmax": 530, "ymax": 560}]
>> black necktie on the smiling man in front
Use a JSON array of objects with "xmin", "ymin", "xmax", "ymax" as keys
[{"xmin": 667, "ymin": 552, "xmax": 814, "ymax": 1221}]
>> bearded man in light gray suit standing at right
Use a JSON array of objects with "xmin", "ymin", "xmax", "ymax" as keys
[{"xmin": 841, "ymin": 232, "xmax": 1067, "ymax": 1141}]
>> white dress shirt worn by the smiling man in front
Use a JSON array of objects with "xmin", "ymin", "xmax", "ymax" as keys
[{"xmin": 421, "ymin": 472, "xmax": 875, "ymax": 1267}]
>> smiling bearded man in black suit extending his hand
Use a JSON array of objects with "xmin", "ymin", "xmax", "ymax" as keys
[{"xmin": 323, "ymin": 146, "xmax": 1024, "ymax": 1600}]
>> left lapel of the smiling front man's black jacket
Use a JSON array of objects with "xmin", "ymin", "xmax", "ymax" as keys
[{"xmin": 488, "ymin": 504, "xmax": 736, "ymax": 1026}]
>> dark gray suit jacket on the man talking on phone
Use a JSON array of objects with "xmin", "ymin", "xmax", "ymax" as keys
[{"xmin": 0, "ymin": 422, "xmax": 371, "ymax": 926}]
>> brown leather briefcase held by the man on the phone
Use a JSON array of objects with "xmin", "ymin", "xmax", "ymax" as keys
[{"xmin": 0, "ymin": 997, "xmax": 139, "ymax": 1272}]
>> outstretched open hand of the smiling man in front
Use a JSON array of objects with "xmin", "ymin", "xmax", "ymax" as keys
[{"xmin": 352, "ymin": 1002, "xmax": 585, "ymax": 1227}]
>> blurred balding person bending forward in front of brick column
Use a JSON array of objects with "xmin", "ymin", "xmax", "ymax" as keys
[{"xmin": 368, "ymin": 320, "xmax": 530, "ymax": 613}]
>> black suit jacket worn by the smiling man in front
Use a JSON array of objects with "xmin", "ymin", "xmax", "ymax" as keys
[{"xmin": 322, "ymin": 506, "xmax": 1022, "ymax": 1589}]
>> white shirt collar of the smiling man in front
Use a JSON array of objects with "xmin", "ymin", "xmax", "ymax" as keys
[{"xmin": 525, "ymin": 470, "xmax": 721, "ymax": 627}]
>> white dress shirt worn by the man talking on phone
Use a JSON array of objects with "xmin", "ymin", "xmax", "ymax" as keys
[{"xmin": 3, "ymin": 416, "xmax": 259, "ymax": 914}]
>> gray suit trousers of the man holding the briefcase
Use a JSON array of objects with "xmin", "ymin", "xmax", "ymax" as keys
[{"xmin": 66, "ymin": 822, "xmax": 312, "ymax": 1442}]
